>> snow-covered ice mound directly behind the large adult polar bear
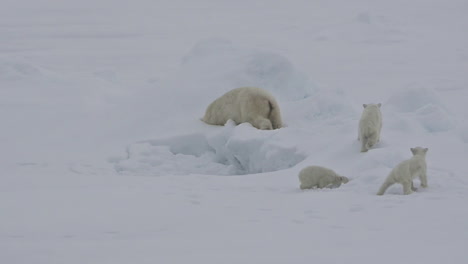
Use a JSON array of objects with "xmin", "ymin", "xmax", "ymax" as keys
[{"xmin": 173, "ymin": 39, "xmax": 314, "ymax": 100}]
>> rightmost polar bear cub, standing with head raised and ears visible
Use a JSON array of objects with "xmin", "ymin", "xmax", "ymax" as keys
[{"xmin": 377, "ymin": 147, "xmax": 428, "ymax": 195}]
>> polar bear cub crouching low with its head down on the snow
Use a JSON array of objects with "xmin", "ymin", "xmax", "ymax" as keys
[{"xmin": 299, "ymin": 166, "xmax": 349, "ymax": 189}]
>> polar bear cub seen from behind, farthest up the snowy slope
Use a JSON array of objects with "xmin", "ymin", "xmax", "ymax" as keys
[{"xmin": 358, "ymin": 103, "xmax": 382, "ymax": 152}]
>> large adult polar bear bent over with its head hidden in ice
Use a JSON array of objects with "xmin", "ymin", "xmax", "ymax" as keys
[{"xmin": 201, "ymin": 87, "xmax": 282, "ymax": 130}]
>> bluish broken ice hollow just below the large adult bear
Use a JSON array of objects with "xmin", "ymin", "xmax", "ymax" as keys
[{"xmin": 114, "ymin": 123, "xmax": 305, "ymax": 176}]
